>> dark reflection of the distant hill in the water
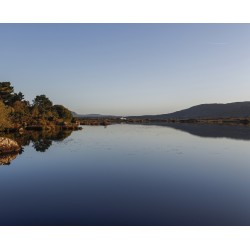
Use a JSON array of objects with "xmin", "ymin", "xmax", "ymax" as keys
[{"xmin": 146, "ymin": 122, "xmax": 250, "ymax": 140}]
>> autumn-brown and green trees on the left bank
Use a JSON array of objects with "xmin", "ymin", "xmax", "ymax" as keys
[{"xmin": 0, "ymin": 82, "xmax": 79, "ymax": 132}]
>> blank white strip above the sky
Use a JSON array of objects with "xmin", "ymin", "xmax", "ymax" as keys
[{"xmin": 0, "ymin": 0, "xmax": 250, "ymax": 23}]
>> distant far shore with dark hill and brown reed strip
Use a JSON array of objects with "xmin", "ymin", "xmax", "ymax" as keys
[{"xmin": 74, "ymin": 101, "xmax": 250, "ymax": 125}]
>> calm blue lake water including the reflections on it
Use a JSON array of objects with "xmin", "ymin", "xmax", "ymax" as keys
[{"xmin": 0, "ymin": 124, "xmax": 250, "ymax": 225}]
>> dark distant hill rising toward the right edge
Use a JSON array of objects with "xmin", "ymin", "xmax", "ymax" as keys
[{"xmin": 128, "ymin": 102, "xmax": 250, "ymax": 119}]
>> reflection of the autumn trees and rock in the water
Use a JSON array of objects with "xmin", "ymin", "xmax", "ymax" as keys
[{"xmin": 0, "ymin": 130, "xmax": 72, "ymax": 165}]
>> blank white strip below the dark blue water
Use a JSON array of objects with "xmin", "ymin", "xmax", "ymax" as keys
[{"xmin": 0, "ymin": 227, "xmax": 249, "ymax": 250}]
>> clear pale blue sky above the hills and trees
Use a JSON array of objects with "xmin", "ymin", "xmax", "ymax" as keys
[{"xmin": 0, "ymin": 24, "xmax": 250, "ymax": 115}]
